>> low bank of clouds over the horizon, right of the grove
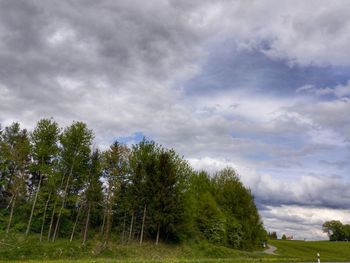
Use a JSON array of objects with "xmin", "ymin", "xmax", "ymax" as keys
[{"xmin": 189, "ymin": 157, "xmax": 350, "ymax": 240}]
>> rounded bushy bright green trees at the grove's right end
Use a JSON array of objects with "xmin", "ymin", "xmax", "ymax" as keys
[{"xmin": 188, "ymin": 168, "xmax": 266, "ymax": 249}]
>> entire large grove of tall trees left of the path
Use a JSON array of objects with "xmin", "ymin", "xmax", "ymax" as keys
[{"xmin": 0, "ymin": 119, "xmax": 266, "ymax": 249}]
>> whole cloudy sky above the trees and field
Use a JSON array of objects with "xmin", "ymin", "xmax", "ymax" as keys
[{"xmin": 0, "ymin": 0, "xmax": 350, "ymax": 240}]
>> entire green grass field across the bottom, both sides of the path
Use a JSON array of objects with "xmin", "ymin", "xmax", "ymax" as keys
[{"xmin": 0, "ymin": 236, "xmax": 350, "ymax": 263}]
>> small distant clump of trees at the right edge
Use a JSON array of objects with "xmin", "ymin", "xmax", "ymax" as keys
[{"xmin": 322, "ymin": 220, "xmax": 350, "ymax": 241}]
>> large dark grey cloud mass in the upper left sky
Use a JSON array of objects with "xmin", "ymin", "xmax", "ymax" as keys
[{"xmin": 0, "ymin": 1, "xmax": 208, "ymax": 142}]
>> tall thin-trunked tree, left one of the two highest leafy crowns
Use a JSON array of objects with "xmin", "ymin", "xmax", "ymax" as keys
[{"xmin": 26, "ymin": 119, "xmax": 60, "ymax": 235}]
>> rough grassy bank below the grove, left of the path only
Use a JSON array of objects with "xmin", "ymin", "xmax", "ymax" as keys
[{"xmin": 0, "ymin": 233, "xmax": 254, "ymax": 262}]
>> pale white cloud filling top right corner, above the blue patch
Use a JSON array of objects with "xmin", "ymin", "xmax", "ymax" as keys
[{"xmin": 205, "ymin": 0, "xmax": 350, "ymax": 66}]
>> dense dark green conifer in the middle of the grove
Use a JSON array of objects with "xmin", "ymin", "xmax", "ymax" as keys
[{"xmin": 147, "ymin": 148, "xmax": 191, "ymax": 244}]
